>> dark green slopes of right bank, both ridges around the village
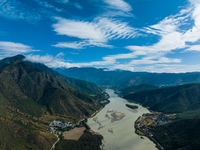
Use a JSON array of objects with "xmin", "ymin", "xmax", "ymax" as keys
[{"xmin": 124, "ymin": 83, "xmax": 200, "ymax": 150}]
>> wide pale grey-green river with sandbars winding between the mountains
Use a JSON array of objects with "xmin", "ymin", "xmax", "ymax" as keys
[{"xmin": 88, "ymin": 89, "xmax": 157, "ymax": 150}]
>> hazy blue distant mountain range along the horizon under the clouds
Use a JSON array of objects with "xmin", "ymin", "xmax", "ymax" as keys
[{"xmin": 57, "ymin": 68, "xmax": 200, "ymax": 89}]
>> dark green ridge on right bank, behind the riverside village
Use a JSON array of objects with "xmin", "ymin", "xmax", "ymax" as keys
[{"xmin": 124, "ymin": 83, "xmax": 200, "ymax": 113}]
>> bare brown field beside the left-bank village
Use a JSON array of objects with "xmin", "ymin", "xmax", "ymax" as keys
[{"xmin": 63, "ymin": 127, "xmax": 86, "ymax": 141}]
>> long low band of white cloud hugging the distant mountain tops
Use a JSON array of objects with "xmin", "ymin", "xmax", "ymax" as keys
[{"xmin": 25, "ymin": 53, "xmax": 200, "ymax": 73}]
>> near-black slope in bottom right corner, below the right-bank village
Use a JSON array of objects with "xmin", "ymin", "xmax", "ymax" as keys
[{"xmin": 154, "ymin": 118, "xmax": 200, "ymax": 150}]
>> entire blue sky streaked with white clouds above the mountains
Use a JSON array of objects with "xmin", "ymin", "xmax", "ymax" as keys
[{"xmin": 0, "ymin": 0, "xmax": 200, "ymax": 73}]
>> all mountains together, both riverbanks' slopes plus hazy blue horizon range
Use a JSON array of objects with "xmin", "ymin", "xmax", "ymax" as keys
[{"xmin": 0, "ymin": 55, "xmax": 200, "ymax": 150}]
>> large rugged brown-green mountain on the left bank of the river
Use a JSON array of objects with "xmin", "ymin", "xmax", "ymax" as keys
[{"xmin": 0, "ymin": 55, "xmax": 104, "ymax": 150}]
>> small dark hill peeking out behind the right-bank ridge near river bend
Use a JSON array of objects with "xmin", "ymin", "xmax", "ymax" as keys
[{"xmin": 119, "ymin": 84, "xmax": 159, "ymax": 96}]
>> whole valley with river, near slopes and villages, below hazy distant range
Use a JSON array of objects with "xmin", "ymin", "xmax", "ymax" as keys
[{"xmin": 0, "ymin": 55, "xmax": 200, "ymax": 150}]
